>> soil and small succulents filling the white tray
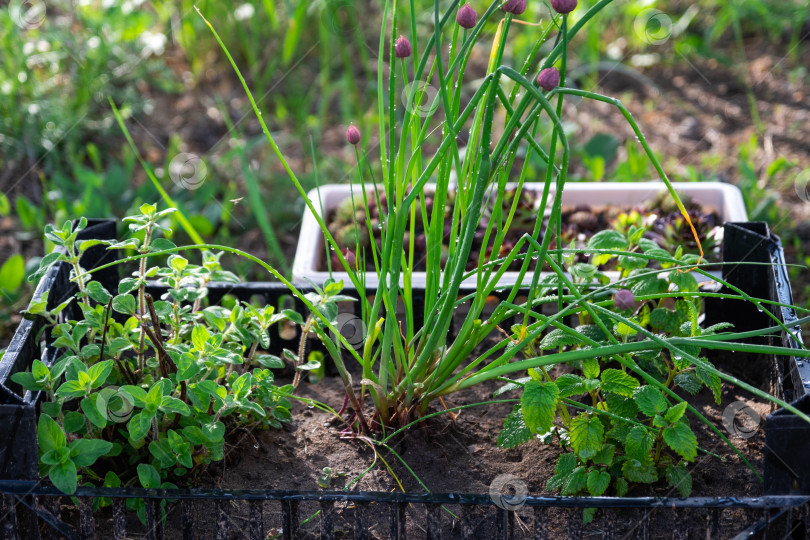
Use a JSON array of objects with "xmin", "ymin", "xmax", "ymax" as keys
[{"xmin": 319, "ymin": 189, "xmax": 722, "ymax": 272}]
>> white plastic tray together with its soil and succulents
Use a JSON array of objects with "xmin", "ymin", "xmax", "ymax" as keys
[{"xmin": 293, "ymin": 182, "xmax": 747, "ymax": 288}]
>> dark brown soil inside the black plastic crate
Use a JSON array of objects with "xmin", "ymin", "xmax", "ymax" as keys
[{"xmin": 71, "ymin": 344, "xmax": 771, "ymax": 538}]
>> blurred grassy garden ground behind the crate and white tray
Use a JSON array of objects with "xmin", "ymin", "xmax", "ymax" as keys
[{"xmin": 0, "ymin": 0, "xmax": 810, "ymax": 345}]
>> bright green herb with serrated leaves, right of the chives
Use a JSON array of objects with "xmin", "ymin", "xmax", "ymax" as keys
[{"xmin": 498, "ymin": 230, "xmax": 731, "ymax": 520}]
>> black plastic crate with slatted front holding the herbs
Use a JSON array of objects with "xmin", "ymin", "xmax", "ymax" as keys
[{"xmin": 0, "ymin": 220, "xmax": 810, "ymax": 539}]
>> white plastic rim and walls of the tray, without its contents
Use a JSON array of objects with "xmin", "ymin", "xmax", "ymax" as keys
[{"xmin": 293, "ymin": 182, "xmax": 748, "ymax": 287}]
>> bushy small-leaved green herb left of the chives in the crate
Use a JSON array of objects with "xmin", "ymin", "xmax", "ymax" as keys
[{"xmin": 12, "ymin": 204, "xmax": 300, "ymax": 498}]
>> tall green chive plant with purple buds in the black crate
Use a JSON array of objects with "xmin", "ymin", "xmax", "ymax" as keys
[{"xmin": 196, "ymin": 0, "xmax": 810, "ymax": 448}]
